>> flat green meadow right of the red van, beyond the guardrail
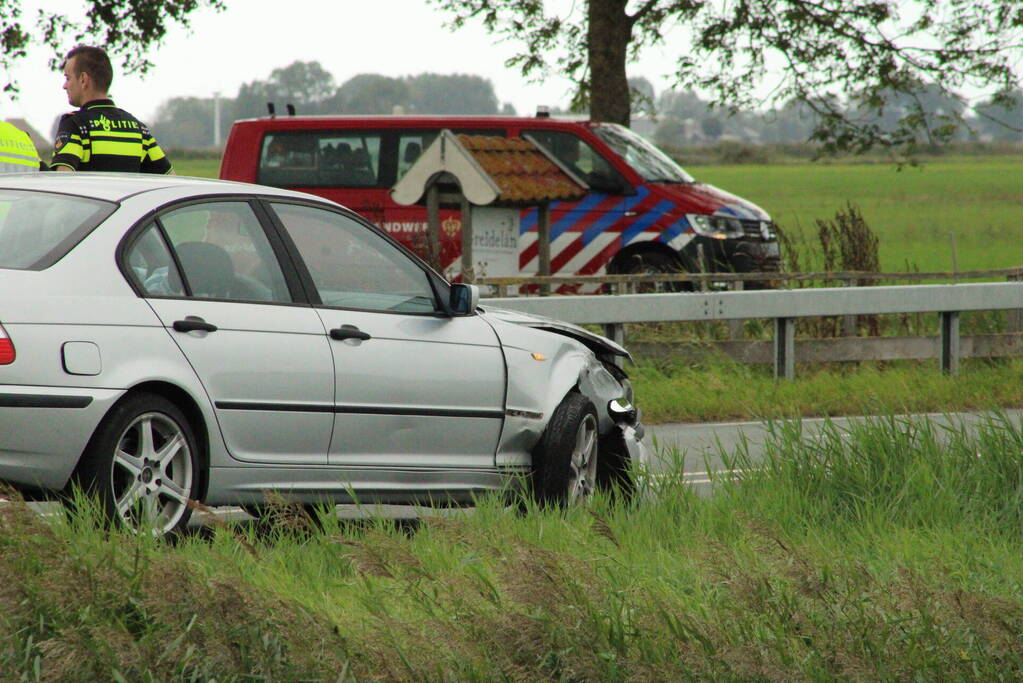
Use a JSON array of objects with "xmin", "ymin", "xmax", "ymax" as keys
[{"xmin": 693, "ymin": 155, "xmax": 1023, "ymax": 271}]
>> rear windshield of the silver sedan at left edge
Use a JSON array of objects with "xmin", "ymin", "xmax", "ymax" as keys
[{"xmin": 0, "ymin": 190, "xmax": 117, "ymax": 270}]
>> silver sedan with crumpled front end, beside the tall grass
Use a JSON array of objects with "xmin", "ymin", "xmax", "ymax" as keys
[{"xmin": 0, "ymin": 174, "xmax": 643, "ymax": 533}]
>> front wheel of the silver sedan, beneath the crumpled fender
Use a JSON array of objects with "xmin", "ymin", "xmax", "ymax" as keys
[{"xmin": 533, "ymin": 392, "xmax": 599, "ymax": 506}]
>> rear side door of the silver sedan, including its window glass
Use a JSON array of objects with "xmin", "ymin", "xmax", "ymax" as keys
[{"xmin": 125, "ymin": 200, "xmax": 333, "ymax": 464}]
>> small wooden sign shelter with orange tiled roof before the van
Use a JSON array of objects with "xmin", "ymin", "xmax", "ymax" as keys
[{"xmin": 391, "ymin": 130, "xmax": 588, "ymax": 282}]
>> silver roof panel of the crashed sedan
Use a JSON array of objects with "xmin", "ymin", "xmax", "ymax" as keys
[{"xmin": 0, "ymin": 173, "xmax": 311, "ymax": 201}]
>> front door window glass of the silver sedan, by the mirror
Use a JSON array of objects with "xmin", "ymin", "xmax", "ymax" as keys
[{"xmin": 272, "ymin": 203, "xmax": 437, "ymax": 313}]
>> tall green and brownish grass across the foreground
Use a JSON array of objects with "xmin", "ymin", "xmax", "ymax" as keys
[{"xmin": 0, "ymin": 417, "xmax": 1023, "ymax": 681}]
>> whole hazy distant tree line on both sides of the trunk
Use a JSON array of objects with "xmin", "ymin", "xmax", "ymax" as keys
[{"xmin": 149, "ymin": 61, "xmax": 1023, "ymax": 148}]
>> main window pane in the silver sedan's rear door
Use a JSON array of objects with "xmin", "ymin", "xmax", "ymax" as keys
[{"xmin": 159, "ymin": 201, "xmax": 292, "ymax": 304}]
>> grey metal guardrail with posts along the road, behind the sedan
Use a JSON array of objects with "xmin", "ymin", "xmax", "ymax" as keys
[{"xmin": 481, "ymin": 282, "xmax": 1023, "ymax": 378}]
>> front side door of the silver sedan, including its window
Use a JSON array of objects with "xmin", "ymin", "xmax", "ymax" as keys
[{"xmin": 261, "ymin": 198, "xmax": 505, "ymax": 467}]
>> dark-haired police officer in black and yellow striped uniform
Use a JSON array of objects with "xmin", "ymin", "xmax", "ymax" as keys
[{"xmin": 50, "ymin": 45, "xmax": 173, "ymax": 174}]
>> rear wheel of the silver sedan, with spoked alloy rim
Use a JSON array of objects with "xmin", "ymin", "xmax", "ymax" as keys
[{"xmin": 79, "ymin": 394, "xmax": 199, "ymax": 536}]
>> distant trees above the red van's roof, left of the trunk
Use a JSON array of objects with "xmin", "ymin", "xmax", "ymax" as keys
[{"xmin": 147, "ymin": 61, "xmax": 515, "ymax": 148}]
